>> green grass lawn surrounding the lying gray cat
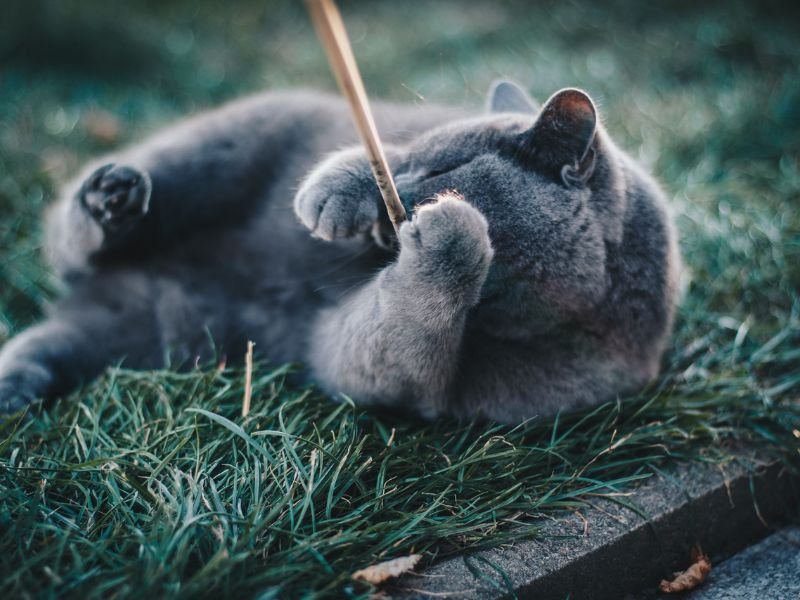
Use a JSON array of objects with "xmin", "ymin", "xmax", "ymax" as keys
[{"xmin": 0, "ymin": 0, "xmax": 800, "ymax": 597}]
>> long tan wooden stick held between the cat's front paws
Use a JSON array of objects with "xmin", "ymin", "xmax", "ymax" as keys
[{"xmin": 307, "ymin": 0, "xmax": 406, "ymax": 231}]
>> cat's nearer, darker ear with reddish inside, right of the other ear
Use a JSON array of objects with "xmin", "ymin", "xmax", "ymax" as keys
[{"xmin": 526, "ymin": 88, "xmax": 597, "ymax": 185}]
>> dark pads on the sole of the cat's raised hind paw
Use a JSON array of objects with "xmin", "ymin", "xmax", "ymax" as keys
[{"xmin": 78, "ymin": 164, "xmax": 152, "ymax": 231}]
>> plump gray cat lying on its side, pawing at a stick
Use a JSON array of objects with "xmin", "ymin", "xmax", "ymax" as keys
[{"xmin": 0, "ymin": 82, "xmax": 679, "ymax": 423}]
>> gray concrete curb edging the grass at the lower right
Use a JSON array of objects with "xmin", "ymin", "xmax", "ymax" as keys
[{"xmin": 396, "ymin": 453, "xmax": 800, "ymax": 599}]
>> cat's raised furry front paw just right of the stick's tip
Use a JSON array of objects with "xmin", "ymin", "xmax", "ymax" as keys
[{"xmin": 400, "ymin": 193, "xmax": 494, "ymax": 302}]
